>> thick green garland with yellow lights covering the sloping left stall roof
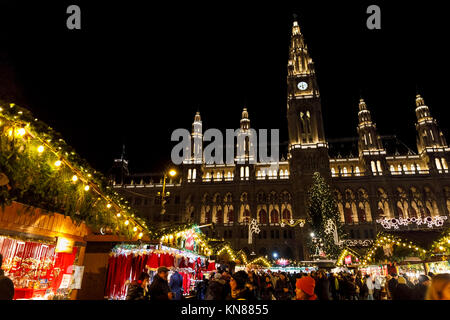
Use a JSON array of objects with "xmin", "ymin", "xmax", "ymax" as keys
[{"xmin": 0, "ymin": 102, "xmax": 148, "ymax": 238}]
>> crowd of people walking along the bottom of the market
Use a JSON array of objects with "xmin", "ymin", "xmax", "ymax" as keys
[{"xmin": 123, "ymin": 267, "xmax": 450, "ymax": 300}]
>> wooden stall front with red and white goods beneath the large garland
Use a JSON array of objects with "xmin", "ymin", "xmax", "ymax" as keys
[{"xmin": 0, "ymin": 202, "xmax": 88, "ymax": 300}]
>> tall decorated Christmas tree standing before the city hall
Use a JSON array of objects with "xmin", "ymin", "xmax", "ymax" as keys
[{"xmin": 307, "ymin": 172, "xmax": 344, "ymax": 258}]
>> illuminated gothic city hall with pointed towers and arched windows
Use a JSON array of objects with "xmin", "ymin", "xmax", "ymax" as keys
[{"xmin": 112, "ymin": 22, "xmax": 450, "ymax": 260}]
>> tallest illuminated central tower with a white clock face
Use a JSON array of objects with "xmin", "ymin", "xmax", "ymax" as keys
[{"xmin": 287, "ymin": 21, "xmax": 331, "ymax": 228}]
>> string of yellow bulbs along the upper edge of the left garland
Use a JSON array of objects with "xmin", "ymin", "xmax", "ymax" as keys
[{"xmin": 0, "ymin": 103, "xmax": 148, "ymax": 239}]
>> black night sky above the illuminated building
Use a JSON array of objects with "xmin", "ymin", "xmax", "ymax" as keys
[{"xmin": 0, "ymin": 0, "xmax": 450, "ymax": 172}]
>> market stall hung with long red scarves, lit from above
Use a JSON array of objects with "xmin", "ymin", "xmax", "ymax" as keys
[{"xmin": 105, "ymin": 229, "xmax": 216, "ymax": 300}]
